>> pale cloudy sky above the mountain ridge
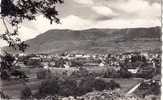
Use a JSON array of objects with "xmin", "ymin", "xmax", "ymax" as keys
[{"xmin": 0, "ymin": 0, "xmax": 161, "ymax": 47}]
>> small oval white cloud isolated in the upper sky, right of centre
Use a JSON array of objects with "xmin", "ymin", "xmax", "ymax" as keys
[{"xmin": 92, "ymin": 6, "xmax": 117, "ymax": 16}]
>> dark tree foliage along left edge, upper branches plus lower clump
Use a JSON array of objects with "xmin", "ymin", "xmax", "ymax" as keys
[{"xmin": 0, "ymin": 0, "xmax": 63, "ymax": 79}]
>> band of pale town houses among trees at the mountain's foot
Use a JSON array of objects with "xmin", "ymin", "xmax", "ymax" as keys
[{"xmin": 13, "ymin": 52, "xmax": 161, "ymax": 74}]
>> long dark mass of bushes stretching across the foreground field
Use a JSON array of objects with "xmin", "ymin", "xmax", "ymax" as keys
[{"xmin": 37, "ymin": 76, "xmax": 120, "ymax": 97}]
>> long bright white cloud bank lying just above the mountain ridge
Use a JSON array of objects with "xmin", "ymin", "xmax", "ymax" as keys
[{"xmin": 31, "ymin": 15, "xmax": 161, "ymax": 32}]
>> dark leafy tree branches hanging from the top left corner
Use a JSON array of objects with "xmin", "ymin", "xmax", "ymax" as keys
[{"xmin": 0, "ymin": 0, "xmax": 63, "ymax": 52}]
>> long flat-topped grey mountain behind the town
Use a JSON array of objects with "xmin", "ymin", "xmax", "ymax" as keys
[{"xmin": 3, "ymin": 27, "xmax": 161, "ymax": 53}]
